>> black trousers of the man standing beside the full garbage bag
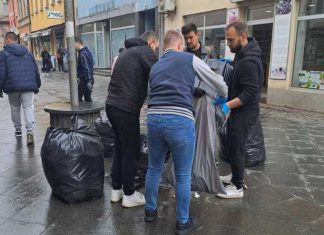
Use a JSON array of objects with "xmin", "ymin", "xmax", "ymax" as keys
[{"xmin": 106, "ymin": 105, "xmax": 140, "ymax": 196}]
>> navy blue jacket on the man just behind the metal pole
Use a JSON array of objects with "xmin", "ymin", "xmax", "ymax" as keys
[{"xmin": 77, "ymin": 47, "xmax": 93, "ymax": 82}]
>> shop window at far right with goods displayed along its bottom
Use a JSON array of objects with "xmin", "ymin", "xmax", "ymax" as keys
[{"xmin": 292, "ymin": 0, "xmax": 324, "ymax": 90}]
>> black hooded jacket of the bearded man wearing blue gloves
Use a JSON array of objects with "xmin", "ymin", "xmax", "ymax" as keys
[{"xmin": 228, "ymin": 38, "xmax": 264, "ymax": 113}]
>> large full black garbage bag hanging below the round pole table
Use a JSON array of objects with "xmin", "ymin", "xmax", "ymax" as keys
[{"xmin": 41, "ymin": 117, "xmax": 105, "ymax": 204}]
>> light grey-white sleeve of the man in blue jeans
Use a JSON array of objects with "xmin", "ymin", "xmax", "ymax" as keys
[{"xmin": 192, "ymin": 56, "xmax": 228, "ymax": 97}]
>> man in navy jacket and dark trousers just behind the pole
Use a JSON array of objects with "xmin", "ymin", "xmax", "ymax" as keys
[{"xmin": 75, "ymin": 38, "xmax": 94, "ymax": 102}]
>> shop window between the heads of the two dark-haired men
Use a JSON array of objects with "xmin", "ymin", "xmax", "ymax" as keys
[{"xmin": 185, "ymin": 10, "xmax": 227, "ymax": 58}]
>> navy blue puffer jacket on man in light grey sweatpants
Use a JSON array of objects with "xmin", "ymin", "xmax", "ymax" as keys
[{"xmin": 0, "ymin": 43, "xmax": 41, "ymax": 93}]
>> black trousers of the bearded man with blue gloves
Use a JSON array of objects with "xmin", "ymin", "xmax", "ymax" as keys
[{"xmin": 228, "ymin": 111, "xmax": 259, "ymax": 189}]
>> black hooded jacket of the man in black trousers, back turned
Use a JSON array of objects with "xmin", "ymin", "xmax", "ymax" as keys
[{"xmin": 106, "ymin": 38, "xmax": 157, "ymax": 115}]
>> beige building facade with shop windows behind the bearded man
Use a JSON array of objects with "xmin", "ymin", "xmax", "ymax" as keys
[{"xmin": 162, "ymin": 0, "xmax": 324, "ymax": 113}]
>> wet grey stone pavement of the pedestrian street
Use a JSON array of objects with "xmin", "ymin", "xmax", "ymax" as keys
[{"xmin": 0, "ymin": 73, "xmax": 324, "ymax": 235}]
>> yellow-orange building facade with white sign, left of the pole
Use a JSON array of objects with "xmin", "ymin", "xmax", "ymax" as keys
[{"xmin": 27, "ymin": 0, "xmax": 65, "ymax": 59}]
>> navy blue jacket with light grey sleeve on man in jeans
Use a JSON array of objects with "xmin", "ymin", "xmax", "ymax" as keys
[{"xmin": 148, "ymin": 50, "xmax": 227, "ymax": 113}]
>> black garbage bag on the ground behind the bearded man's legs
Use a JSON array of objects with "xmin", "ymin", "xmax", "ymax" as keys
[{"xmin": 219, "ymin": 118, "xmax": 266, "ymax": 167}]
